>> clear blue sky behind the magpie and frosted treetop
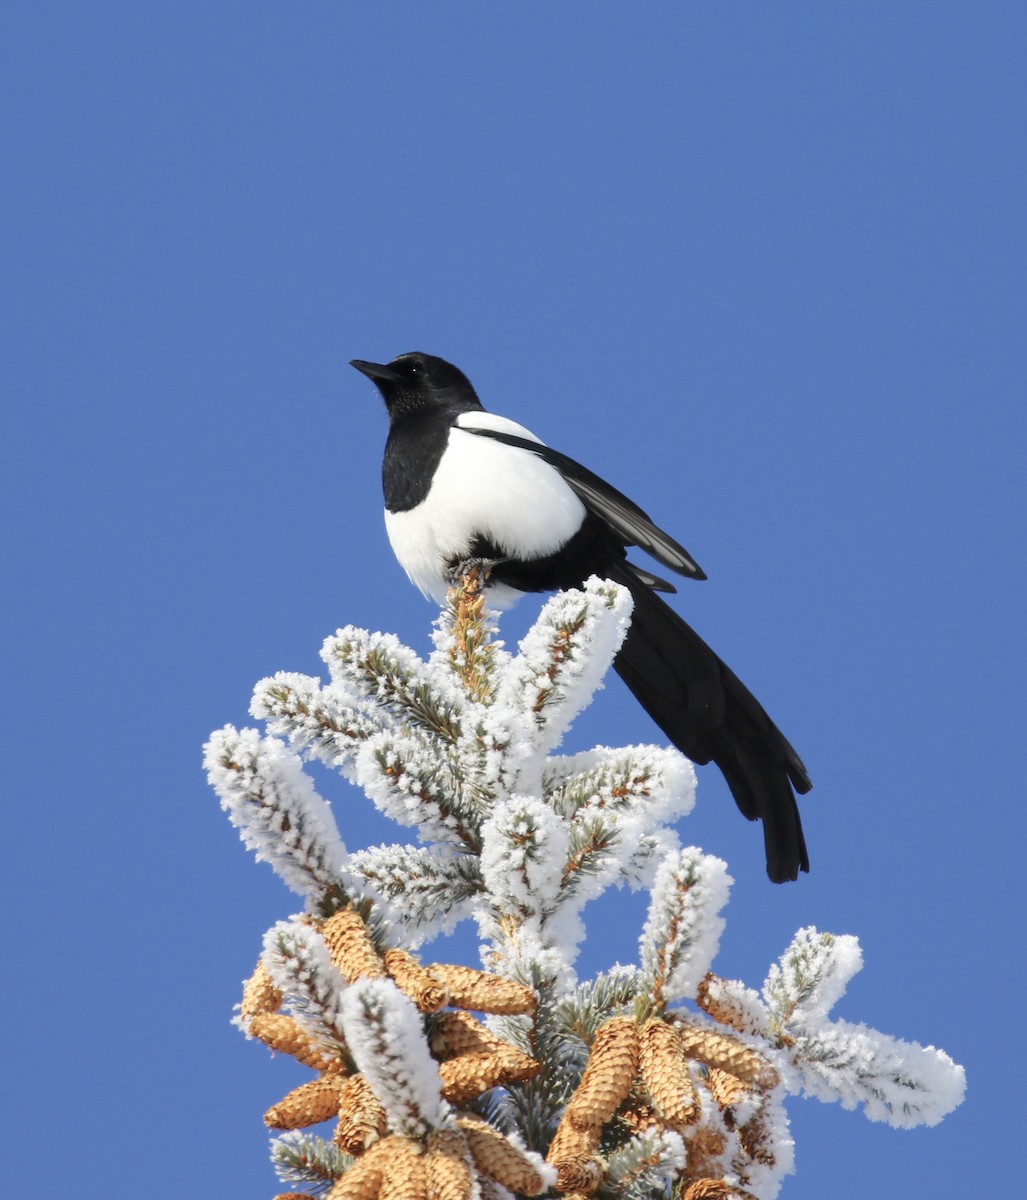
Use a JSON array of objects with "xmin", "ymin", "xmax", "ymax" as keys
[{"xmin": 0, "ymin": 0, "xmax": 1027, "ymax": 1200}]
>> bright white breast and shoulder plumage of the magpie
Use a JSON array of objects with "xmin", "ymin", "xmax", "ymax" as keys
[{"xmin": 385, "ymin": 413, "xmax": 585, "ymax": 607}]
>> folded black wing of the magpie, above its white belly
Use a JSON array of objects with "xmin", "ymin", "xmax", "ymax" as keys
[{"xmin": 460, "ymin": 425, "xmax": 707, "ymax": 580}]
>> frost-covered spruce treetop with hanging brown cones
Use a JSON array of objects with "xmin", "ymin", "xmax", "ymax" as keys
[{"xmin": 205, "ymin": 572, "xmax": 965, "ymax": 1200}]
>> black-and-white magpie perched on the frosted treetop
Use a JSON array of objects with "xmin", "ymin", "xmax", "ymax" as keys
[{"xmin": 350, "ymin": 352, "xmax": 812, "ymax": 883}]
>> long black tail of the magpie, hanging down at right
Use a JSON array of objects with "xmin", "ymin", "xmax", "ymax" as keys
[{"xmin": 613, "ymin": 563, "xmax": 812, "ymax": 883}]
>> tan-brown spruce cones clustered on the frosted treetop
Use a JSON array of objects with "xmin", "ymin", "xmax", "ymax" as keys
[{"xmin": 241, "ymin": 908, "xmax": 779, "ymax": 1200}]
